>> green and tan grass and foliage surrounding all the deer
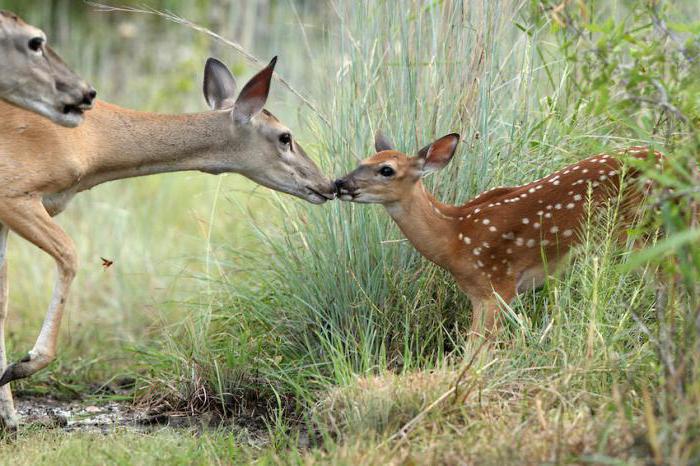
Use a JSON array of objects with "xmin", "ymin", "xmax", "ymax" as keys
[{"xmin": 0, "ymin": 0, "xmax": 700, "ymax": 464}]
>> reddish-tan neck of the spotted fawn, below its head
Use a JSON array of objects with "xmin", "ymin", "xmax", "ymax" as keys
[{"xmin": 385, "ymin": 180, "xmax": 458, "ymax": 270}]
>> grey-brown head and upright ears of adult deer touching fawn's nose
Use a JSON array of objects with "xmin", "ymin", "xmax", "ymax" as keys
[{"xmin": 204, "ymin": 57, "xmax": 335, "ymax": 204}]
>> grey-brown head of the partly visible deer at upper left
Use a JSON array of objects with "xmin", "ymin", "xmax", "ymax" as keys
[{"xmin": 0, "ymin": 10, "xmax": 97, "ymax": 128}]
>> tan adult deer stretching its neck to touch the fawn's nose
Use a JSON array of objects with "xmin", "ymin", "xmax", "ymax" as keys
[{"xmin": 0, "ymin": 58, "xmax": 335, "ymax": 426}]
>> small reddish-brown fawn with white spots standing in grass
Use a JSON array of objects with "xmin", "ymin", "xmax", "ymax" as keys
[{"xmin": 335, "ymin": 133, "xmax": 660, "ymax": 334}]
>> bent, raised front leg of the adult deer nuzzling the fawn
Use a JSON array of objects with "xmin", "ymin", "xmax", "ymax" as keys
[{"xmin": 0, "ymin": 199, "xmax": 77, "ymax": 387}]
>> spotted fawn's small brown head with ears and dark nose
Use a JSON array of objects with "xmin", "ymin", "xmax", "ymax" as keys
[{"xmin": 335, "ymin": 132, "xmax": 459, "ymax": 204}]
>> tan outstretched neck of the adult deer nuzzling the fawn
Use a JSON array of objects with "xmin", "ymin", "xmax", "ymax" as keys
[{"xmin": 79, "ymin": 102, "xmax": 237, "ymax": 191}]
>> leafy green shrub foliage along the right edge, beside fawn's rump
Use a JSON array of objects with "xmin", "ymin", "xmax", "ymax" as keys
[{"xmin": 531, "ymin": 0, "xmax": 700, "ymax": 463}]
